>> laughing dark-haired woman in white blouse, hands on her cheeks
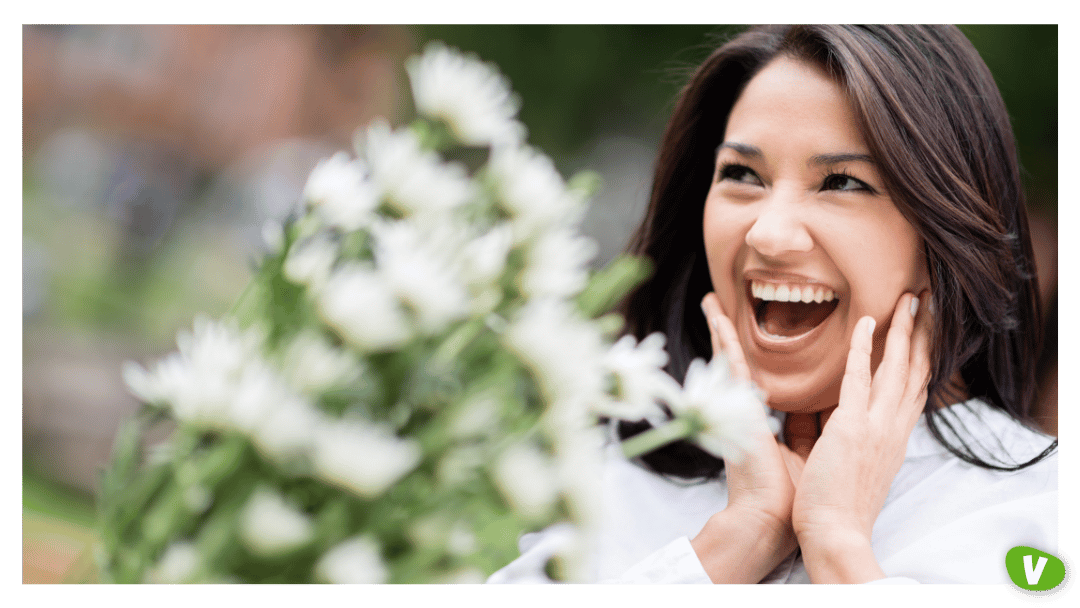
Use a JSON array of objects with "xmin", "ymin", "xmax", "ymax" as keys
[{"xmin": 491, "ymin": 26, "xmax": 1057, "ymax": 584}]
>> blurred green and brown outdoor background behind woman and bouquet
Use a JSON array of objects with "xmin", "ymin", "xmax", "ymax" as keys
[{"xmin": 23, "ymin": 25, "xmax": 1058, "ymax": 583}]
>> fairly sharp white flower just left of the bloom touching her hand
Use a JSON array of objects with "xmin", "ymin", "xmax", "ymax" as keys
[{"xmin": 603, "ymin": 333, "xmax": 681, "ymax": 420}]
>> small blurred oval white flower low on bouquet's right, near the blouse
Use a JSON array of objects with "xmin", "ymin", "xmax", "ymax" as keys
[{"xmin": 494, "ymin": 444, "xmax": 559, "ymax": 519}]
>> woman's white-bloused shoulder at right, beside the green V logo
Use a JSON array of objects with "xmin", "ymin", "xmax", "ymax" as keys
[{"xmin": 874, "ymin": 400, "xmax": 1057, "ymax": 584}]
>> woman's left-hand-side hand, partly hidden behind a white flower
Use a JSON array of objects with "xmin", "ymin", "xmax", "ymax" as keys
[{"xmin": 690, "ymin": 293, "xmax": 802, "ymax": 584}]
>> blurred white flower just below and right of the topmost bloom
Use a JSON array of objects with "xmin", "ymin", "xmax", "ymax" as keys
[{"xmin": 488, "ymin": 147, "xmax": 585, "ymax": 235}]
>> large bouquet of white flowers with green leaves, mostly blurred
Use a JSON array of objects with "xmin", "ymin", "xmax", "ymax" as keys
[{"xmin": 99, "ymin": 43, "xmax": 760, "ymax": 583}]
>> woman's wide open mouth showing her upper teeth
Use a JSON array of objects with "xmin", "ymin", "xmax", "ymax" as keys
[{"xmin": 747, "ymin": 281, "xmax": 840, "ymax": 338}]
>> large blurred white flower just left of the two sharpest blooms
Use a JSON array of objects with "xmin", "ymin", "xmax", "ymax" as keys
[{"xmin": 503, "ymin": 299, "xmax": 605, "ymax": 404}]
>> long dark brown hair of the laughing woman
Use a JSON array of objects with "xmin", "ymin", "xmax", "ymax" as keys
[{"xmin": 620, "ymin": 25, "xmax": 1056, "ymax": 477}]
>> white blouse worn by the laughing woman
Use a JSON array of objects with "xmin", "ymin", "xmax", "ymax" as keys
[{"xmin": 488, "ymin": 400, "xmax": 1057, "ymax": 584}]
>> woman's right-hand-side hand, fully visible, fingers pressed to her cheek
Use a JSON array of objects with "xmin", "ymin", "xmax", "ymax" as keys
[{"xmin": 792, "ymin": 293, "xmax": 931, "ymax": 583}]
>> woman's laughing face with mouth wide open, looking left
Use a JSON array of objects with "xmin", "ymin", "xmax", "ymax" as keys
[{"xmin": 704, "ymin": 57, "xmax": 929, "ymax": 411}]
